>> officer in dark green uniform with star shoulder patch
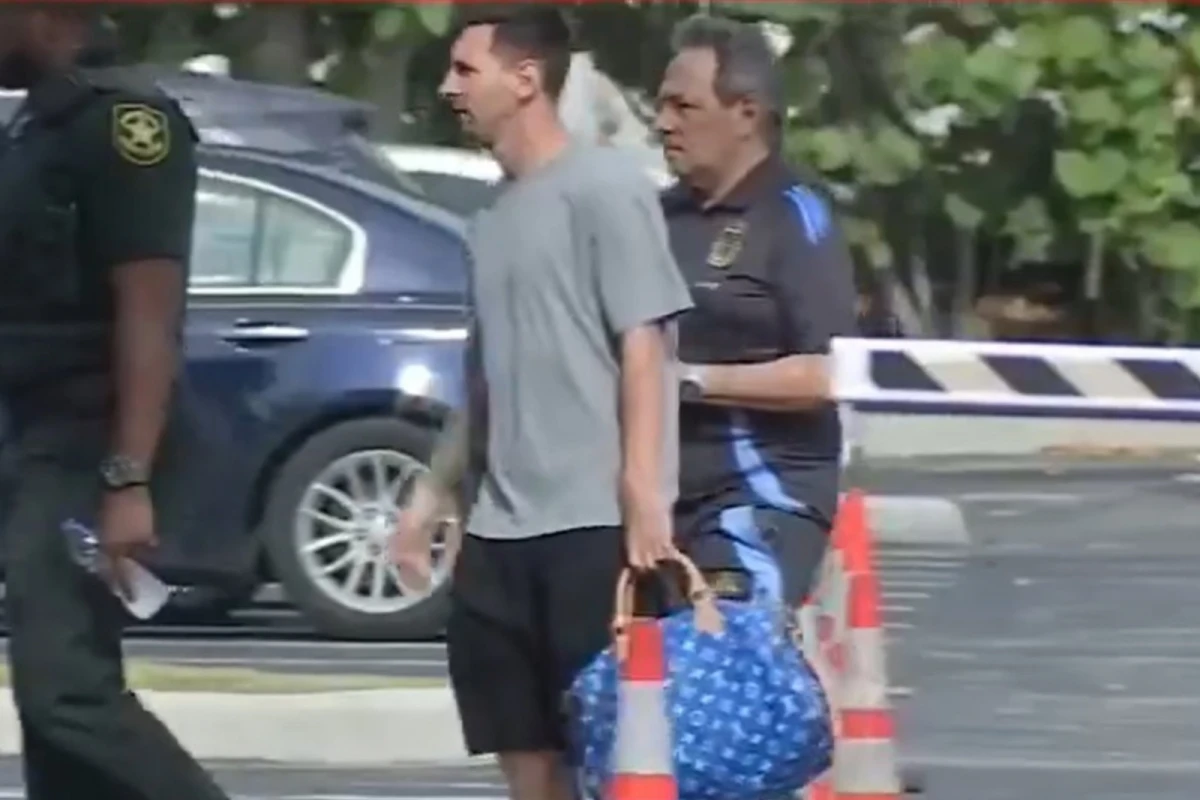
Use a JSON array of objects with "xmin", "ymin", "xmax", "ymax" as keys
[{"xmin": 0, "ymin": 4, "xmax": 226, "ymax": 800}]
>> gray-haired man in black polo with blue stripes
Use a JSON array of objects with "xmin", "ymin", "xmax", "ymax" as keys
[{"xmin": 656, "ymin": 17, "xmax": 856, "ymax": 607}]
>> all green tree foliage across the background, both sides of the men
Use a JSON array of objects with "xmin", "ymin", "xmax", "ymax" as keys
[{"xmin": 108, "ymin": 0, "xmax": 1200, "ymax": 339}]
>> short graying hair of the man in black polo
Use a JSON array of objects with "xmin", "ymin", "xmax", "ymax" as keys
[{"xmin": 671, "ymin": 14, "xmax": 785, "ymax": 122}]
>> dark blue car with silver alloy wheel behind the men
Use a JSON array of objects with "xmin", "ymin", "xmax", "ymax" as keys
[{"xmin": 0, "ymin": 78, "xmax": 466, "ymax": 639}]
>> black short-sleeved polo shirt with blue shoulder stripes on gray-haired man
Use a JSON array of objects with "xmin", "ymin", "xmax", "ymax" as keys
[{"xmin": 664, "ymin": 158, "xmax": 856, "ymax": 532}]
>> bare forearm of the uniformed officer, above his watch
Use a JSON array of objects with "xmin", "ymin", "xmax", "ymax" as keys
[{"xmin": 112, "ymin": 260, "xmax": 185, "ymax": 464}]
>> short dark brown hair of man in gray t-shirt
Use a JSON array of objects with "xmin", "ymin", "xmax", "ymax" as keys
[{"xmin": 455, "ymin": 2, "xmax": 572, "ymax": 100}]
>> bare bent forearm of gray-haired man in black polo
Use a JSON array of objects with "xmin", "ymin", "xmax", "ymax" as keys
[{"xmin": 684, "ymin": 355, "xmax": 833, "ymax": 411}]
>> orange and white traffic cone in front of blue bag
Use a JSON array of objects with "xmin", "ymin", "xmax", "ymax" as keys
[{"xmin": 607, "ymin": 618, "xmax": 679, "ymax": 800}]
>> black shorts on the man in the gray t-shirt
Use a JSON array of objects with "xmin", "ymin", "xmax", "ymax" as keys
[{"xmin": 446, "ymin": 528, "xmax": 625, "ymax": 756}]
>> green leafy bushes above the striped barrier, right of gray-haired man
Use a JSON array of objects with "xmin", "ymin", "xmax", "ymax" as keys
[{"xmin": 727, "ymin": 2, "xmax": 1200, "ymax": 338}]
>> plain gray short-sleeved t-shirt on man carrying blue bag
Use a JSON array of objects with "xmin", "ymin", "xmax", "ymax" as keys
[{"xmin": 467, "ymin": 144, "xmax": 691, "ymax": 539}]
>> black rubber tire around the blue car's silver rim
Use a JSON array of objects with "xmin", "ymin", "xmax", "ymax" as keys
[{"xmin": 262, "ymin": 417, "xmax": 450, "ymax": 640}]
